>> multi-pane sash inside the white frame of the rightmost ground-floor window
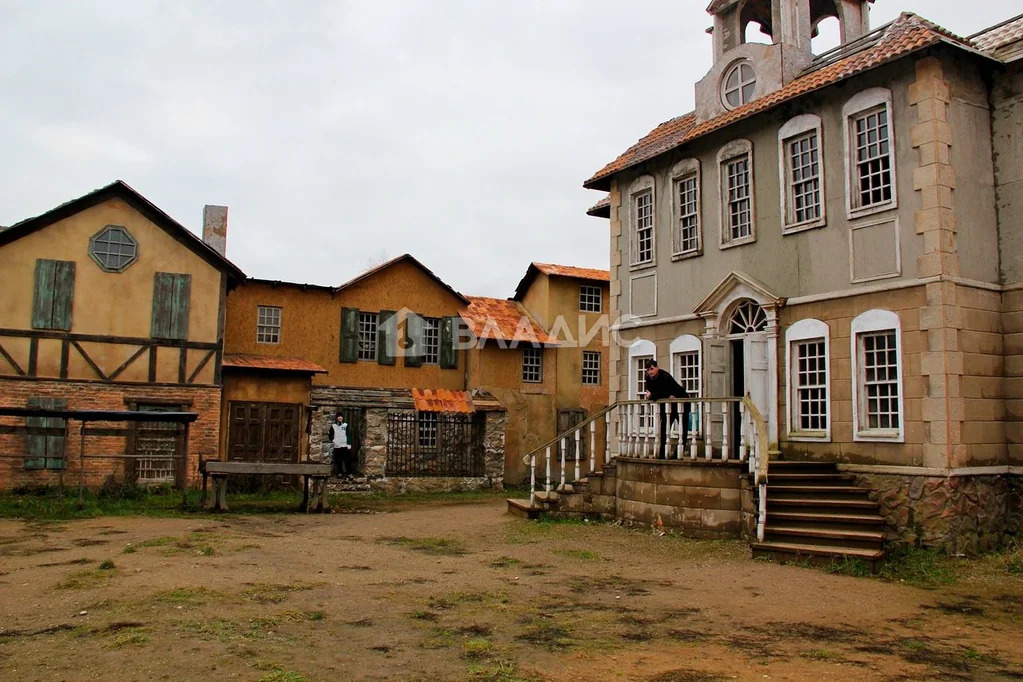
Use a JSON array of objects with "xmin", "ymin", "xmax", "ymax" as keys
[{"xmin": 858, "ymin": 329, "xmax": 901, "ymax": 430}]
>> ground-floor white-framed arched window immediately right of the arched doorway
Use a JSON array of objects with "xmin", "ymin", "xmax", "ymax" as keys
[{"xmin": 785, "ymin": 319, "xmax": 831, "ymax": 441}]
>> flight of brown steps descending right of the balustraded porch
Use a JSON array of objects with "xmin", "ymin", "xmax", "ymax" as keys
[{"xmin": 751, "ymin": 461, "xmax": 885, "ymax": 572}]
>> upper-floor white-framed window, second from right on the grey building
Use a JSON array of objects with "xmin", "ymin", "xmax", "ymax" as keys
[{"xmin": 777, "ymin": 113, "xmax": 825, "ymax": 232}]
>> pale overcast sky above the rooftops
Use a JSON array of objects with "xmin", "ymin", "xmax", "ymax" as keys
[{"xmin": 0, "ymin": 0, "xmax": 1020, "ymax": 298}]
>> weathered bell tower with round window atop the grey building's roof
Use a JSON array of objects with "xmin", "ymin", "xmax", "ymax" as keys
[{"xmin": 696, "ymin": 0, "xmax": 874, "ymax": 121}]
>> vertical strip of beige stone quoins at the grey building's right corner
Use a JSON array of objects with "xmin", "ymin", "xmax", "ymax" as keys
[{"xmin": 909, "ymin": 57, "xmax": 967, "ymax": 466}]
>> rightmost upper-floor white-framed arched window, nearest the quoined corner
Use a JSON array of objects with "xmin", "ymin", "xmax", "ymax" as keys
[{"xmin": 842, "ymin": 88, "xmax": 897, "ymax": 218}]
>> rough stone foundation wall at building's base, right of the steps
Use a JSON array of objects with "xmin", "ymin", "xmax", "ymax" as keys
[{"xmin": 857, "ymin": 473, "xmax": 1023, "ymax": 556}]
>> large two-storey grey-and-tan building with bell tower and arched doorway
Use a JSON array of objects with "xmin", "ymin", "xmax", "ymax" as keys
[{"xmin": 585, "ymin": 0, "xmax": 1023, "ymax": 549}]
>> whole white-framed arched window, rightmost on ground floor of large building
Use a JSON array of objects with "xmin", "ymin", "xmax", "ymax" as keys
[{"xmin": 851, "ymin": 310, "xmax": 905, "ymax": 443}]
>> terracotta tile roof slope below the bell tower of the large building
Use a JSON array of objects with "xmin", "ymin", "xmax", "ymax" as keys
[{"xmin": 583, "ymin": 12, "xmax": 972, "ymax": 191}]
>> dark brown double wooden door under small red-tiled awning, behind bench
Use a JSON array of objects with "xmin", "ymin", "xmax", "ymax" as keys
[{"xmin": 227, "ymin": 401, "xmax": 302, "ymax": 462}]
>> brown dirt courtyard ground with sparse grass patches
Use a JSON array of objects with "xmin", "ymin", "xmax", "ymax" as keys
[{"xmin": 0, "ymin": 500, "xmax": 1023, "ymax": 682}]
